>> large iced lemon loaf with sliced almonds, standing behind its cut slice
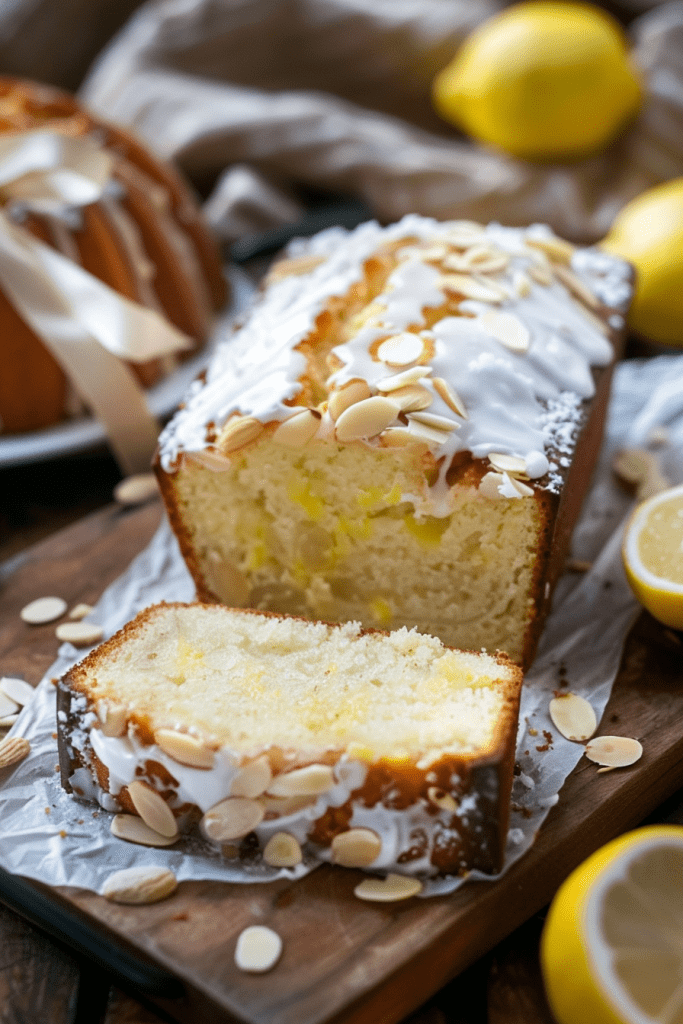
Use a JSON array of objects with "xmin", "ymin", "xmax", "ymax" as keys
[{"xmin": 158, "ymin": 215, "xmax": 632, "ymax": 666}]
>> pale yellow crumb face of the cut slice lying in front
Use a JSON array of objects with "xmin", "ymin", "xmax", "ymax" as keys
[{"xmin": 89, "ymin": 605, "xmax": 513, "ymax": 759}]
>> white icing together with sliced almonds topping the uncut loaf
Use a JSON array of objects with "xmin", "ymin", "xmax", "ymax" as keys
[{"xmin": 160, "ymin": 215, "xmax": 631, "ymax": 501}]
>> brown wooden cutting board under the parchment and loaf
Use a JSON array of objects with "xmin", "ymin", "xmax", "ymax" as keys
[{"xmin": 0, "ymin": 503, "xmax": 683, "ymax": 1024}]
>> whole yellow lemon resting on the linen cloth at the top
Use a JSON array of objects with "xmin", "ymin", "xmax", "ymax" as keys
[{"xmin": 432, "ymin": 2, "xmax": 641, "ymax": 161}]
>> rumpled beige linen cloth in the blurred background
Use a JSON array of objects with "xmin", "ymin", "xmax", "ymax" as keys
[{"xmin": 72, "ymin": 0, "xmax": 683, "ymax": 242}]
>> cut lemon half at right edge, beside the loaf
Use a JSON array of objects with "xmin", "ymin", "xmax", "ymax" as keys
[{"xmin": 622, "ymin": 484, "xmax": 683, "ymax": 630}]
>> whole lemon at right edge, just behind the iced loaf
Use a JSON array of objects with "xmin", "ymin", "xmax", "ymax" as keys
[{"xmin": 600, "ymin": 178, "xmax": 683, "ymax": 345}]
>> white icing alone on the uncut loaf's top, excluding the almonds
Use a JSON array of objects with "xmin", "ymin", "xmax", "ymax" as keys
[{"xmin": 160, "ymin": 215, "xmax": 631, "ymax": 503}]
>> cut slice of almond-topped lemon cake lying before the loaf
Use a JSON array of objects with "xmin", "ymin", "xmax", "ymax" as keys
[{"xmin": 57, "ymin": 603, "xmax": 521, "ymax": 874}]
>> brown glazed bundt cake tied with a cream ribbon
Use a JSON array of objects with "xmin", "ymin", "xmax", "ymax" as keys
[{"xmin": 0, "ymin": 78, "xmax": 226, "ymax": 433}]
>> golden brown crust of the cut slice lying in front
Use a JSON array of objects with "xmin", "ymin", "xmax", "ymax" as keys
[{"xmin": 57, "ymin": 602, "xmax": 522, "ymax": 873}]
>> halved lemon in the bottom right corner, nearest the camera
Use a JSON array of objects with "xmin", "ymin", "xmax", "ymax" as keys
[{"xmin": 541, "ymin": 825, "xmax": 683, "ymax": 1024}]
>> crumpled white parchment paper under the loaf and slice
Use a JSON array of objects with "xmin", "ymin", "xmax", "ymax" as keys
[{"xmin": 0, "ymin": 354, "xmax": 683, "ymax": 895}]
